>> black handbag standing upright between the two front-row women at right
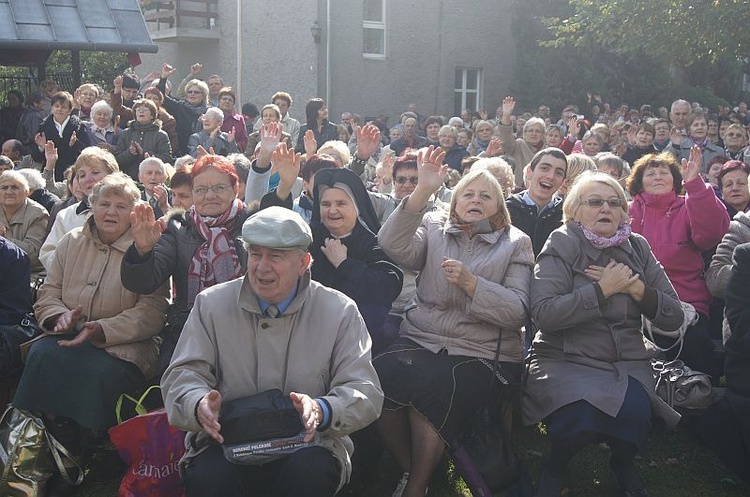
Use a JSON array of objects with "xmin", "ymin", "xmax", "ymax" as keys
[{"xmin": 449, "ymin": 328, "xmax": 531, "ymax": 497}]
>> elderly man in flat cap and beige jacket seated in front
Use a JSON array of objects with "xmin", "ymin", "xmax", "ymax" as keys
[{"xmin": 161, "ymin": 207, "xmax": 383, "ymax": 497}]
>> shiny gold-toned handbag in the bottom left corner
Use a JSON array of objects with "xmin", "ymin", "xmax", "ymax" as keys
[{"xmin": 0, "ymin": 405, "xmax": 83, "ymax": 497}]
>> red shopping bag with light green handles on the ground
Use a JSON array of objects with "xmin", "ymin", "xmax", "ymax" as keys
[{"xmin": 109, "ymin": 385, "xmax": 185, "ymax": 497}]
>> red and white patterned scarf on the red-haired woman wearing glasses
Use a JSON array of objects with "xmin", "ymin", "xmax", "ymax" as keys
[{"xmin": 187, "ymin": 199, "xmax": 245, "ymax": 306}]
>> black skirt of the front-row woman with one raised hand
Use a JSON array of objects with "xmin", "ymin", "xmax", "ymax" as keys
[{"xmin": 373, "ymin": 337, "xmax": 516, "ymax": 444}]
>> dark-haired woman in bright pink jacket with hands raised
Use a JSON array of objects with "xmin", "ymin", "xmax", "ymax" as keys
[{"xmin": 627, "ymin": 147, "xmax": 729, "ymax": 381}]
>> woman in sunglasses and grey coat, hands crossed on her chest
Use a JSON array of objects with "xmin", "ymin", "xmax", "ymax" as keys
[{"xmin": 522, "ymin": 172, "xmax": 684, "ymax": 497}]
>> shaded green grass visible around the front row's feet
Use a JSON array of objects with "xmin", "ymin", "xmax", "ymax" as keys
[{"xmin": 75, "ymin": 416, "xmax": 750, "ymax": 497}]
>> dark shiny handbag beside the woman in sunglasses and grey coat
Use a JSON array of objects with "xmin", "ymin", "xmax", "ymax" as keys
[{"xmin": 651, "ymin": 359, "xmax": 716, "ymax": 409}]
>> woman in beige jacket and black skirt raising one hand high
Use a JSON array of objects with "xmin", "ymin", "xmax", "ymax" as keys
[{"xmin": 373, "ymin": 147, "xmax": 534, "ymax": 496}]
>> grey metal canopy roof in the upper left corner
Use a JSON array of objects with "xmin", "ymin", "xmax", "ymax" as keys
[{"xmin": 0, "ymin": 0, "xmax": 158, "ymax": 55}]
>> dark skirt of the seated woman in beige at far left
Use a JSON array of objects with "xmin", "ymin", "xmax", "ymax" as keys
[{"xmin": 12, "ymin": 335, "xmax": 146, "ymax": 430}]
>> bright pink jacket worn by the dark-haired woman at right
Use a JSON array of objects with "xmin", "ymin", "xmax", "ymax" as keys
[{"xmin": 630, "ymin": 178, "xmax": 729, "ymax": 316}]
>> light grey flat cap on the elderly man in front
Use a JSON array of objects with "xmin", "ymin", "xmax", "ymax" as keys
[{"xmin": 242, "ymin": 207, "xmax": 312, "ymax": 250}]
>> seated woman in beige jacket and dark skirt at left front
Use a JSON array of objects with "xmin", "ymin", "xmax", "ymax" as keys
[{"xmin": 13, "ymin": 172, "xmax": 167, "ymax": 490}]
